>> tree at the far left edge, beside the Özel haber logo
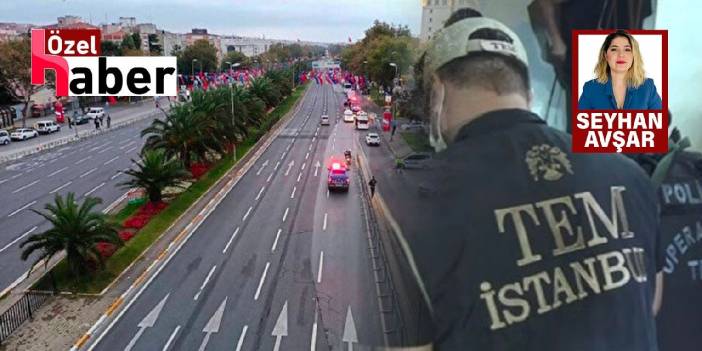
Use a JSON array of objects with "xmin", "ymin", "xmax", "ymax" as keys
[{"xmin": 0, "ymin": 37, "xmax": 42, "ymax": 127}]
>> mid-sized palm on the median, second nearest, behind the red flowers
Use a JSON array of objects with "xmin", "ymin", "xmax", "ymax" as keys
[{"xmin": 118, "ymin": 149, "xmax": 189, "ymax": 203}]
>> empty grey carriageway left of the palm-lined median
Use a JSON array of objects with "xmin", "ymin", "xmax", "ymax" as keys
[{"xmin": 0, "ymin": 118, "xmax": 157, "ymax": 291}]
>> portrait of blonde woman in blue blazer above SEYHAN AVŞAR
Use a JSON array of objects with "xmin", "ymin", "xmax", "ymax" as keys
[{"xmin": 578, "ymin": 30, "xmax": 663, "ymax": 110}]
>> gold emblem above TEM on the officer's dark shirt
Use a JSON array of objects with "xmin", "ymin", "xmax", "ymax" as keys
[{"xmin": 525, "ymin": 144, "xmax": 573, "ymax": 182}]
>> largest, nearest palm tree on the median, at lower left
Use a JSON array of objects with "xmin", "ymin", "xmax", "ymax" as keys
[{"xmin": 20, "ymin": 193, "xmax": 122, "ymax": 282}]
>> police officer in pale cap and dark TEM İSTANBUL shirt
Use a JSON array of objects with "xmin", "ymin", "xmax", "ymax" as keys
[{"xmin": 400, "ymin": 11, "xmax": 662, "ymax": 351}]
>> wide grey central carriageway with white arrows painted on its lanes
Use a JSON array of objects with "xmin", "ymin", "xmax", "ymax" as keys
[{"xmin": 82, "ymin": 85, "xmax": 394, "ymax": 350}]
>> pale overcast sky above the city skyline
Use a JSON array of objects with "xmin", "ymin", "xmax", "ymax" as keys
[{"xmin": 0, "ymin": 0, "xmax": 421, "ymax": 42}]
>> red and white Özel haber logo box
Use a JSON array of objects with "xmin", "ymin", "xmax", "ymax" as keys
[{"xmin": 32, "ymin": 29, "xmax": 177, "ymax": 96}]
